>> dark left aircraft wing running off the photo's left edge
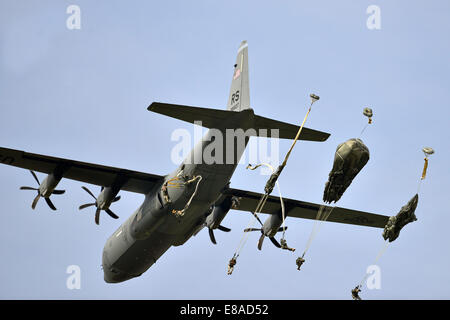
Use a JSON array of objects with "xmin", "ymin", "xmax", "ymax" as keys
[{"xmin": 0, "ymin": 148, "xmax": 163, "ymax": 194}]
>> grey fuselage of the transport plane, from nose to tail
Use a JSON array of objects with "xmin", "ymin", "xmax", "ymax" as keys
[{"xmin": 102, "ymin": 109, "xmax": 254, "ymax": 283}]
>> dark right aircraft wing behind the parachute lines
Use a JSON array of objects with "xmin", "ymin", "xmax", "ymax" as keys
[{"xmin": 223, "ymin": 188, "xmax": 389, "ymax": 228}]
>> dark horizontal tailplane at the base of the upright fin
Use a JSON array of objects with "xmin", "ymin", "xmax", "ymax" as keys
[{"xmin": 148, "ymin": 102, "xmax": 330, "ymax": 141}]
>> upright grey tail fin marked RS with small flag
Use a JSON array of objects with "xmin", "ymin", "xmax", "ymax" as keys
[{"xmin": 227, "ymin": 40, "xmax": 250, "ymax": 111}]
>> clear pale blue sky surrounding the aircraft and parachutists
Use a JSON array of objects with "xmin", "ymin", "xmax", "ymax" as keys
[{"xmin": 0, "ymin": 0, "xmax": 450, "ymax": 299}]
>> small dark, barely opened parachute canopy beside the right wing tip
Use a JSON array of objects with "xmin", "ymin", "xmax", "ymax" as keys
[{"xmin": 383, "ymin": 194, "xmax": 419, "ymax": 242}]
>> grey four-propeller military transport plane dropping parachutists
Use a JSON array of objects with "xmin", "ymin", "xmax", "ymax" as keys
[{"xmin": 0, "ymin": 41, "xmax": 389, "ymax": 283}]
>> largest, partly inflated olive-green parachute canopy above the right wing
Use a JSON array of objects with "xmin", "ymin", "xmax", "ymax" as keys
[{"xmin": 323, "ymin": 139, "xmax": 369, "ymax": 203}]
